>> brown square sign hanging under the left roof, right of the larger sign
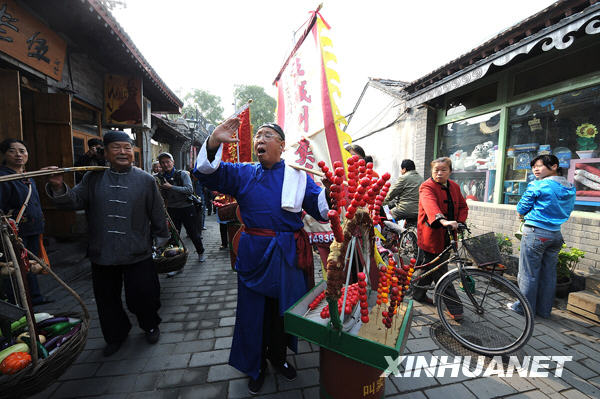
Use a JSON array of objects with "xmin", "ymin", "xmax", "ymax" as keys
[{"xmin": 104, "ymin": 74, "xmax": 143, "ymax": 126}]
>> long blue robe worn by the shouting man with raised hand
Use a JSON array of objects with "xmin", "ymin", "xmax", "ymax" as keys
[{"xmin": 194, "ymin": 156, "xmax": 325, "ymax": 379}]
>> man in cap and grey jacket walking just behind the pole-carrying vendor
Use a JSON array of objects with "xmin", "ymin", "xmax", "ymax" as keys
[{"xmin": 158, "ymin": 152, "xmax": 205, "ymax": 262}]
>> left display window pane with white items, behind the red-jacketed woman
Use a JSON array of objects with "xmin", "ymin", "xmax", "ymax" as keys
[{"xmin": 438, "ymin": 111, "xmax": 500, "ymax": 202}]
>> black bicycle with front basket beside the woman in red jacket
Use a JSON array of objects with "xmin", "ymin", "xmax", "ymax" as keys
[{"xmin": 410, "ymin": 224, "xmax": 534, "ymax": 356}]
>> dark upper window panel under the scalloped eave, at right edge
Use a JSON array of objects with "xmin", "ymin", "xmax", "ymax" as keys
[{"xmin": 514, "ymin": 41, "xmax": 600, "ymax": 95}]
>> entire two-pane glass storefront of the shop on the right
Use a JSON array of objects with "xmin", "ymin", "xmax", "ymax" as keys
[{"xmin": 437, "ymin": 86, "xmax": 600, "ymax": 212}]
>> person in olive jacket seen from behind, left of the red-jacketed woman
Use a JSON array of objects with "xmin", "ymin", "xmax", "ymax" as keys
[{"xmin": 383, "ymin": 159, "xmax": 423, "ymax": 221}]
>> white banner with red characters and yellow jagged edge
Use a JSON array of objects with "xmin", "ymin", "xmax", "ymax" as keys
[{"xmin": 275, "ymin": 12, "xmax": 350, "ymax": 178}]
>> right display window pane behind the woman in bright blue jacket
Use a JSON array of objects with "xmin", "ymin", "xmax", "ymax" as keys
[{"xmin": 503, "ymin": 86, "xmax": 600, "ymax": 211}]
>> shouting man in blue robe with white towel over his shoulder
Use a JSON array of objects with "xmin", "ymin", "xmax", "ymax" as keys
[{"xmin": 194, "ymin": 118, "xmax": 329, "ymax": 394}]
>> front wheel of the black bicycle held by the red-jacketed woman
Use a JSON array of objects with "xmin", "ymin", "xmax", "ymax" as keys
[{"xmin": 434, "ymin": 267, "xmax": 533, "ymax": 356}]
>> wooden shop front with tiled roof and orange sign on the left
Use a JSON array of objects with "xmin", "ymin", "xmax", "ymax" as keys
[{"xmin": 0, "ymin": 0, "xmax": 182, "ymax": 235}]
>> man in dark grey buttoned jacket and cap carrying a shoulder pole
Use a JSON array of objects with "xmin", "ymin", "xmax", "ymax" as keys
[{"xmin": 45, "ymin": 131, "xmax": 169, "ymax": 356}]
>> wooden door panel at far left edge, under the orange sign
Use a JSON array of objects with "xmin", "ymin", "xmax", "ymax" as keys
[{"xmin": 0, "ymin": 69, "xmax": 23, "ymax": 141}]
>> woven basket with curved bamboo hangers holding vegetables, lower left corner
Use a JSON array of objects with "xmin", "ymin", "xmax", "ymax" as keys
[{"xmin": 0, "ymin": 233, "xmax": 90, "ymax": 398}]
